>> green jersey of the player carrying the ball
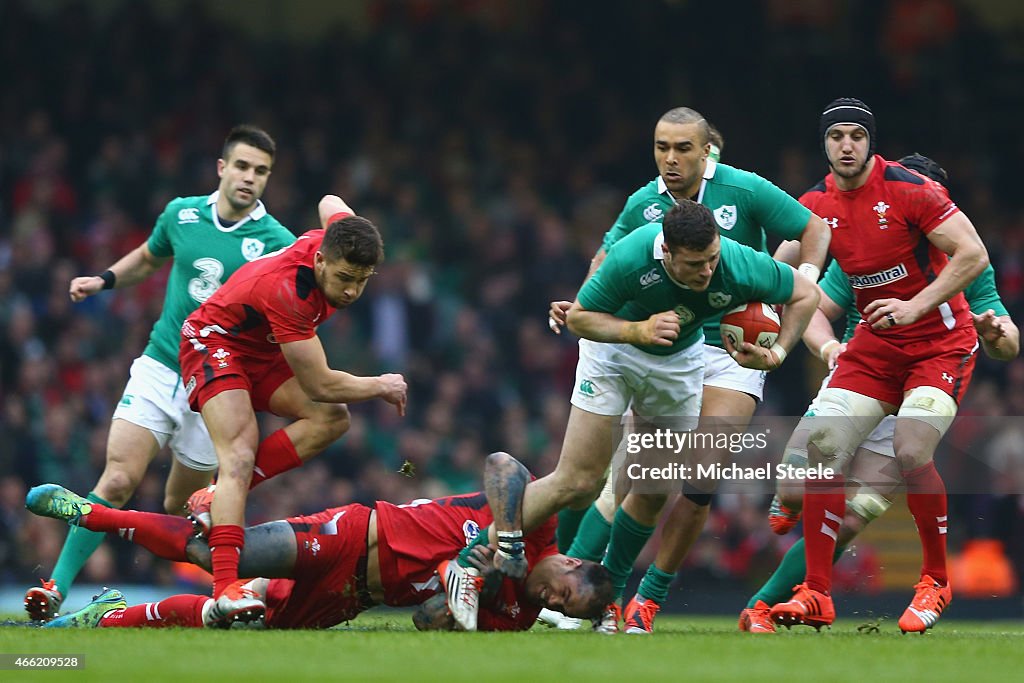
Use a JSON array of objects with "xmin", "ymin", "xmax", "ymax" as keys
[{"xmin": 578, "ymin": 223, "xmax": 794, "ymax": 355}]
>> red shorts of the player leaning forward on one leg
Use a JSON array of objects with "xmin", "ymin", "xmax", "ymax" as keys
[{"xmin": 178, "ymin": 334, "xmax": 295, "ymax": 413}]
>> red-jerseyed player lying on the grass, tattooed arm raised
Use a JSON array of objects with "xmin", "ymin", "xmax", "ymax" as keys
[{"xmin": 26, "ymin": 453, "xmax": 611, "ymax": 631}]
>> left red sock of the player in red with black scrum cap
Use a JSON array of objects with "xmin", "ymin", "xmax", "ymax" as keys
[{"xmin": 804, "ymin": 474, "xmax": 846, "ymax": 595}]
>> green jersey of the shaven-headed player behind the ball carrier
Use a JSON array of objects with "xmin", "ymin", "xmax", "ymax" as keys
[{"xmin": 601, "ymin": 159, "xmax": 811, "ymax": 346}]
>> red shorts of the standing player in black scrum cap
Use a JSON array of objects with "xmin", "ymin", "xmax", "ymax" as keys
[{"xmin": 828, "ymin": 325, "xmax": 978, "ymax": 405}]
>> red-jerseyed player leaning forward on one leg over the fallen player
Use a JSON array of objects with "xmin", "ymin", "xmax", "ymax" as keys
[{"xmin": 179, "ymin": 196, "xmax": 406, "ymax": 620}]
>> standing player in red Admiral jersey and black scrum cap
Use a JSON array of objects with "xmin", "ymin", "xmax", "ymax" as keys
[{"xmin": 771, "ymin": 98, "xmax": 988, "ymax": 632}]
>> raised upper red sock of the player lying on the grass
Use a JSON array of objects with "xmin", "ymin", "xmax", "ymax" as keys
[{"xmin": 81, "ymin": 503, "xmax": 196, "ymax": 562}]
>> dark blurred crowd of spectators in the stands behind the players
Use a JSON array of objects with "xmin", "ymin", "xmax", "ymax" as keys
[{"xmin": 0, "ymin": 0, "xmax": 1024, "ymax": 592}]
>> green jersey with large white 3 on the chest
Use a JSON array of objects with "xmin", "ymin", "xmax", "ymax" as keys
[{"xmin": 142, "ymin": 190, "xmax": 295, "ymax": 373}]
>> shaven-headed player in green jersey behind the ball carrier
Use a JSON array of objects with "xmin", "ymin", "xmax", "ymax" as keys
[{"xmin": 549, "ymin": 108, "xmax": 830, "ymax": 633}]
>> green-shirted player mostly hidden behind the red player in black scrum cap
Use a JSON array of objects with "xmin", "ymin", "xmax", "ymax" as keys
[{"xmin": 739, "ymin": 154, "xmax": 1020, "ymax": 633}]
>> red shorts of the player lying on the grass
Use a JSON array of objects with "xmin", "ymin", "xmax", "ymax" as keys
[{"xmin": 266, "ymin": 504, "xmax": 374, "ymax": 629}]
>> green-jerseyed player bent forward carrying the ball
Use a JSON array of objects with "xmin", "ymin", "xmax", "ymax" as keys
[{"xmin": 449, "ymin": 200, "xmax": 818, "ymax": 632}]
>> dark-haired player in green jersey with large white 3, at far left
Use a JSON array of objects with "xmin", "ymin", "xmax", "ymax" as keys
[{"xmin": 25, "ymin": 126, "xmax": 303, "ymax": 621}]
